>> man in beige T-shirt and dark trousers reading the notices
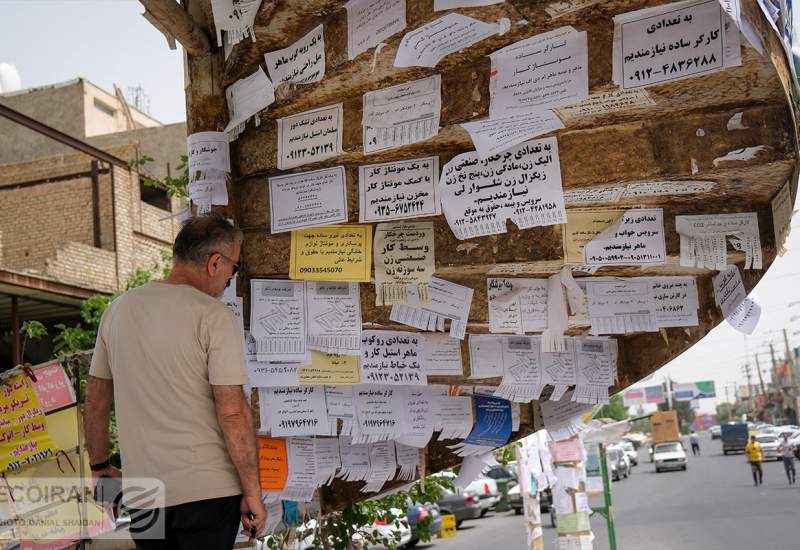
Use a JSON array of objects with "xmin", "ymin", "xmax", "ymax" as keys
[{"xmin": 85, "ymin": 216, "xmax": 266, "ymax": 550}]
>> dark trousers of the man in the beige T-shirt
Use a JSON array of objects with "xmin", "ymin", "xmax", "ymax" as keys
[{"xmin": 129, "ymin": 495, "xmax": 242, "ymax": 550}]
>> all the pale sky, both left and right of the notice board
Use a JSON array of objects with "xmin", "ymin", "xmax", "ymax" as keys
[{"xmin": 0, "ymin": 0, "xmax": 800, "ymax": 418}]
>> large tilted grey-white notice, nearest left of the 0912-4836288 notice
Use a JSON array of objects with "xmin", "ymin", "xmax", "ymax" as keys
[{"xmin": 489, "ymin": 27, "xmax": 589, "ymax": 119}]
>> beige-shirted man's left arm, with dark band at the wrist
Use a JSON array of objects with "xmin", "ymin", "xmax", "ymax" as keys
[{"xmin": 84, "ymin": 375, "xmax": 119, "ymax": 477}]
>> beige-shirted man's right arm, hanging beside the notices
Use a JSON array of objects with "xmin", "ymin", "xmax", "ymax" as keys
[{"xmin": 211, "ymin": 385, "xmax": 267, "ymax": 533}]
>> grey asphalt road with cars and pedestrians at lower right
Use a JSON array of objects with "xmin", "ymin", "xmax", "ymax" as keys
[{"xmin": 418, "ymin": 435, "xmax": 800, "ymax": 550}]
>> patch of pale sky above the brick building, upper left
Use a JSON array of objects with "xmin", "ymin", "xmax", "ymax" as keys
[{"xmin": 0, "ymin": 0, "xmax": 186, "ymax": 123}]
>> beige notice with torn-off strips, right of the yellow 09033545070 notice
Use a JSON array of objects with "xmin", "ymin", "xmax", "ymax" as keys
[{"xmin": 375, "ymin": 222, "xmax": 436, "ymax": 306}]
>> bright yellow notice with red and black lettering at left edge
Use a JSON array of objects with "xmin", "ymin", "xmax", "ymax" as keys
[{"xmin": 0, "ymin": 374, "xmax": 57, "ymax": 472}]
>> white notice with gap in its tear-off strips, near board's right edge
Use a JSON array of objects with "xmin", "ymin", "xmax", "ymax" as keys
[{"xmin": 675, "ymin": 212, "xmax": 762, "ymax": 270}]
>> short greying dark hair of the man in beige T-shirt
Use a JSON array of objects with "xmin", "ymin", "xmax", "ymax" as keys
[{"xmin": 172, "ymin": 214, "xmax": 243, "ymax": 264}]
